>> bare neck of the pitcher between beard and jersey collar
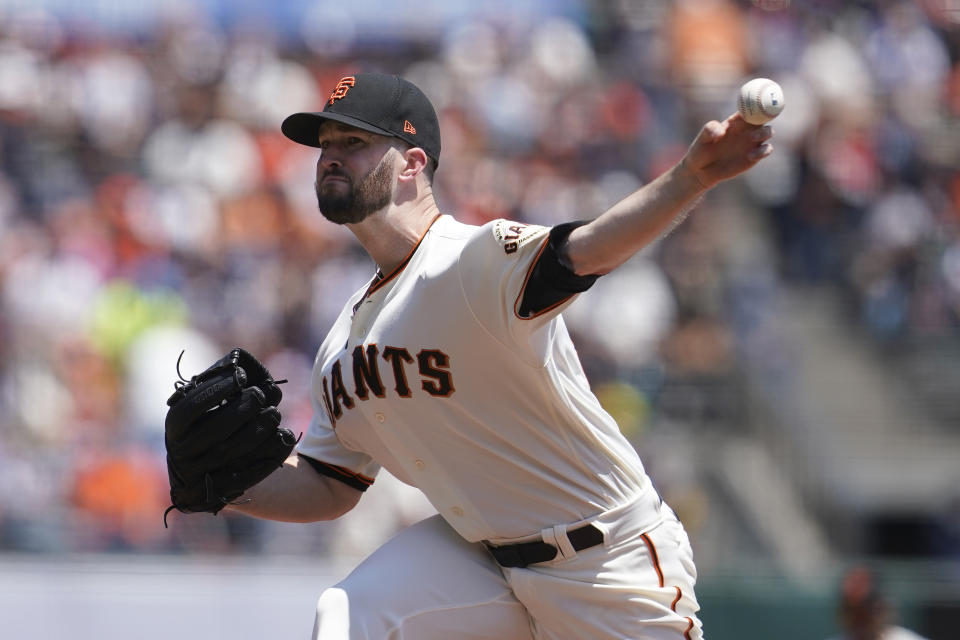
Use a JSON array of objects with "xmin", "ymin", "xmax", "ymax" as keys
[{"xmin": 347, "ymin": 196, "xmax": 440, "ymax": 274}]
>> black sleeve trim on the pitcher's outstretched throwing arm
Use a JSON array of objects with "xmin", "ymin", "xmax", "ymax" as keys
[{"xmin": 513, "ymin": 221, "xmax": 600, "ymax": 320}]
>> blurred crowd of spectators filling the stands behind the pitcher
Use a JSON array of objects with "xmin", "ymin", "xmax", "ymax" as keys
[{"xmin": 0, "ymin": 0, "xmax": 960, "ymax": 551}]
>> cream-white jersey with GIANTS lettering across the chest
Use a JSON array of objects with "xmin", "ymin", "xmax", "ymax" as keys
[{"xmin": 298, "ymin": 215, "xmax": 659, "ymax": 542}]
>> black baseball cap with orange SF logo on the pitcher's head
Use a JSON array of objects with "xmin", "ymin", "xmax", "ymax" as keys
[{"xmin": 280, "ymin": 73, "xmax": 440, "ymax": 165}]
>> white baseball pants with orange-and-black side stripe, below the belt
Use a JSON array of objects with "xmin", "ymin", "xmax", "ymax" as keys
[{"xmin": 313, "ymin": 498, "xmax": 703, "ymax": 640}]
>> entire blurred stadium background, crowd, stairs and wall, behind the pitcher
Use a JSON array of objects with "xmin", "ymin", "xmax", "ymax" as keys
[{"xmin": 0, "ymin": 0, "xmax": 960, "ymax": 640}]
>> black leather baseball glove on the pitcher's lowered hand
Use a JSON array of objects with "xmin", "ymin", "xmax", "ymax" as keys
[{"xmin": 163, "ymin": 348, "xmax": 297, "ymax": 526}]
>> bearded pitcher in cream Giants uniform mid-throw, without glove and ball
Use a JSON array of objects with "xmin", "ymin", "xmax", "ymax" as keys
[{"xmin": 165, "ymin": 74, "xmax": 772, "ymax": 640}]
